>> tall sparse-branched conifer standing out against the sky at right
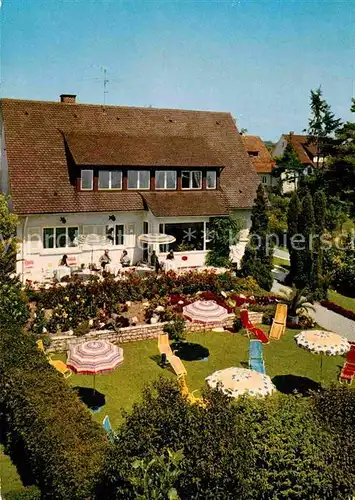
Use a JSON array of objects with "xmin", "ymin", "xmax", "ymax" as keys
[{"xmin": 307, "ymin": 86, "xmax": 341, "ymax": 166}]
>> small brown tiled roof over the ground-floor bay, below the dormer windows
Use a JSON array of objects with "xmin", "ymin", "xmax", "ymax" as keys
[{"xmin": 141, "ymin": 191, "xmax": 229, "ymax": 217}]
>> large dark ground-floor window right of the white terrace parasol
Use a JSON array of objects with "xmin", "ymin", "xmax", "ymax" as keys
[{"xmin": 159, "ymin": 222, "xmax": 206, "ymax": 252}]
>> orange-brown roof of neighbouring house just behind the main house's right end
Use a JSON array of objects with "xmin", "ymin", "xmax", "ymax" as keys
[{"xmin": 242, "ymin": 135, "xmax": 277, "ymax": 187}]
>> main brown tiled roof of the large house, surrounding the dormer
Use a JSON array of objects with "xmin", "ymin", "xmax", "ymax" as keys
[{"xmin": 1, "ymin": 99, "xmax": 259, "ymax": 214}]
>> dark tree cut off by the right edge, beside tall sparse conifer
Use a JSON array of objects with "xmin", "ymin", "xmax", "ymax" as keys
[{"xmin": 326, "ymin": 98, "xmax": 355, "ymax": 216}]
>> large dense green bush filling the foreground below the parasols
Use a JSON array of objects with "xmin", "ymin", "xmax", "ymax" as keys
[{"xmin": 97, "ymin": 380, "xmax": 355, "ymax": 500}]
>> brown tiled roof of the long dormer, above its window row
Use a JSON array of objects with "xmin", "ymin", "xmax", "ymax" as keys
[{"xmin": 64, "ymin": 132, "xmax": 223, "ymax": 167}]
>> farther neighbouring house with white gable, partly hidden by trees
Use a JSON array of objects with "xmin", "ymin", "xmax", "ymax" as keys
[{"xmin": 272, "ymin": 132, "xmax": 326, "ymax": 193}]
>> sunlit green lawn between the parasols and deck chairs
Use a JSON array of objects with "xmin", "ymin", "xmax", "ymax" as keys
[{"xmin": 53, "ymin": 330, "xmax": 344, "ymax": 427}]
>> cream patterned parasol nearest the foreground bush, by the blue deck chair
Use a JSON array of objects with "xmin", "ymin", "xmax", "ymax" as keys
[{"xmin": 206, "ymin": 366, "xmax": 276, "ymax": 398}]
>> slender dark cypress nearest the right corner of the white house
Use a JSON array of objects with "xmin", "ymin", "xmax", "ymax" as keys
[{"xmin": 241, "ymin": 184, "xmax": 273, "ymax": 290}]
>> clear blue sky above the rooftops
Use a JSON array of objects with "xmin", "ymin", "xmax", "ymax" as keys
[{"xmin": 1, "ymin": 0, "xmax": 355, "ymax": 140}]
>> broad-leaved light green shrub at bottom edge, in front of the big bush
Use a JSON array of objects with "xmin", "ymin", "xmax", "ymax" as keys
[{"xmin": 129, "ymin": 448, "xmax": 183, "ymax": 500}]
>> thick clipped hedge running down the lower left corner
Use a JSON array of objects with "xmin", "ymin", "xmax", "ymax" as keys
[{"xmin": 0, "ymin": 328, "xmax": 108, "ymax": 500}]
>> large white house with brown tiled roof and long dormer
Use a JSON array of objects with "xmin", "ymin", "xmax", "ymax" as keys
[{"xmin": 1, "ymin": 94, "xmax": 259, "ymax": 279}]
